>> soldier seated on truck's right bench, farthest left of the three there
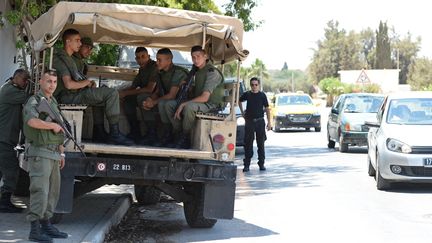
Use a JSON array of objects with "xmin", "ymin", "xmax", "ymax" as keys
[{"xmin": 120, "ymin": 47, "xmax": 157, "ymax": 145}]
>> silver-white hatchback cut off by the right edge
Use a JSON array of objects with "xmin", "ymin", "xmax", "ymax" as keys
[{"xmin": 366, "ymin": 91, "xmax": 432, "ymax": 190}]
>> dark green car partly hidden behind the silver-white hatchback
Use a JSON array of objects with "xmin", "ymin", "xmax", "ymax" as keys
[{"xmin": 327, "ymin": 93, "xmax": 384, "ymax": 152}]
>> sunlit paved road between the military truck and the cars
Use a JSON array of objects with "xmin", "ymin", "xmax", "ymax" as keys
[{"xmin": 120, "ymin": 110, "xmax": 432, "ymax": 243}]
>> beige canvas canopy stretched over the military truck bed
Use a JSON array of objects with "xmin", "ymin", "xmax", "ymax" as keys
[{"xmin": 30, "ymin": 2, "xmax": 248, "ymax": 64}]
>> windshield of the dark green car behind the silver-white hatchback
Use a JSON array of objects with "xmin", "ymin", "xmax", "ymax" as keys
[{"xmin": 343, "ymin": 95, "xmax": 384, "ymax": 113}]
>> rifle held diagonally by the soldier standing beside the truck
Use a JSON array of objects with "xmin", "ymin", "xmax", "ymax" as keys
[{"xmin": 36, "ymin": 97, "xmax": 85, "ymax": 157}]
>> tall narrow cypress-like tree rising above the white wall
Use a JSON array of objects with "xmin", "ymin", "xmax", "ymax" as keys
[{"xmin": 374, "ymin": 21, "xmax": 392, "ymax": 69}]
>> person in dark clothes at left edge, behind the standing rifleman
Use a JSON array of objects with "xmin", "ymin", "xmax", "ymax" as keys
[{"xmin": 0, "ymin": 69, "xmax": 30, "ymax": 213}]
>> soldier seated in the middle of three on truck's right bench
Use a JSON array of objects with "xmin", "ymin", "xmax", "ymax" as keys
[{"xmin": 142, "ymin": 48, "xmax": 187, "ymax": 147}]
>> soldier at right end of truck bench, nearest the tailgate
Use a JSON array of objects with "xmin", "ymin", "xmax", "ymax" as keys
[{"xmin": 167, "ymin": 46, "xmax": 224, "ymax": 149}]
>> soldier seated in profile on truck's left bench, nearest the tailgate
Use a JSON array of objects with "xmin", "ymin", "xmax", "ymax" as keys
[{"xmin": 53, "ymin": 29, "xmax": 133, "ymax": 145}]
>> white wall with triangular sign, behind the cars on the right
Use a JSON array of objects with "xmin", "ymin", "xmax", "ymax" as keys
[{"xmin": 339, "ymin": 69, "xmax": 400, "ymax": 93}]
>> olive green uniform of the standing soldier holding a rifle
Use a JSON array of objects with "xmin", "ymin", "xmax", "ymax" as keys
[{"xmin": 23, "ymin": 91, "xmax": 64, "ymax": 222}]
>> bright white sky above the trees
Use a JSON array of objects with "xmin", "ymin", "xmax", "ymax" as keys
[{"xmin": 215, "ymin": 0, "xmax": 432, "ymax": 70}]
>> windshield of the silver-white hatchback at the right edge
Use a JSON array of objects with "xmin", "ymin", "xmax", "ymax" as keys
[{"xmin": 387, "ymin": 98, "xmax": 432, "ymax": 125}]
